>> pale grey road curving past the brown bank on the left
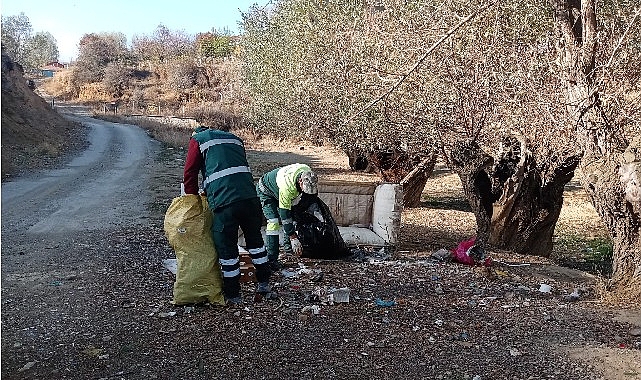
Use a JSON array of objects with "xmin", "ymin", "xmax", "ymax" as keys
[{"xmin": 2, "ymin": 117, "xmax": 158, "ymax": 239}]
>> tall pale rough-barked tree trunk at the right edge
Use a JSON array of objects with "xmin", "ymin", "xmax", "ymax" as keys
[{"xmin": 553, "ymin": 0, "xmax": 641, "ymax": 299}]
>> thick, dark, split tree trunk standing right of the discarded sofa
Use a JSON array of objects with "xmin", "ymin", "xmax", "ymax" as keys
[{"xmin": 451, "ymin": 137, "xmax": 579, "ymax": 257}]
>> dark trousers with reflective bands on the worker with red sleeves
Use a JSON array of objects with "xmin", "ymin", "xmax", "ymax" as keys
[{"xmin": 211, "ymin": 198, "xmax": 271, "ymax": 299}]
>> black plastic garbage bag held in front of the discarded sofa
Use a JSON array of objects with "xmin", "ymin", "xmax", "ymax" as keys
[{"xmin": 292, "ymin": 194, "xmax": 350, "ymax": 260}]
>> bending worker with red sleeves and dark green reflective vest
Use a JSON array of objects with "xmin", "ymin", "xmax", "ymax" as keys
[{"xmin": 183, "ymin": 127, "xmax": 271, "ymax": 304}]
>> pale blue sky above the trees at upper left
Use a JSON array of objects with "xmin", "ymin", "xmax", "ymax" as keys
[{"xmin": 0, "ymin": 0, "xmax": 269, "ymax": 62}]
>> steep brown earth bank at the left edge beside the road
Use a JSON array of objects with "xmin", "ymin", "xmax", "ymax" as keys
[{"xmin": 1, "ymin": 54, "xmax": 84, "ymax": 181}]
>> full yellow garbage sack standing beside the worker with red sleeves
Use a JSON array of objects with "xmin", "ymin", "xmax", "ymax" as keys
[{"xmin": 164, "ymin": 194, "xmax": 225, "ymax": 305}]
